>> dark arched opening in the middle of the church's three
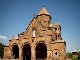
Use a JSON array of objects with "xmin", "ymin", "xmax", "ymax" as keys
[{"xmin": 23, "ymin": 44, "xmax": 31, "ymax": 60}]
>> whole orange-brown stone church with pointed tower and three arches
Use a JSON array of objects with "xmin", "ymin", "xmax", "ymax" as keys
[{"xmin": 3, "ymin": 6, "xmax": 66, "ymax": 60}]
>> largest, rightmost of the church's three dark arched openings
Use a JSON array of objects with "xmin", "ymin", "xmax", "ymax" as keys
[{"xmin": 36, "ymin": 43, "xmax": 47, "ymax": 60}]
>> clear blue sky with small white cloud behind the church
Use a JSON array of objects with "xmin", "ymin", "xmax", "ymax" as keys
[{"xmin": 0, "ymin": 0, "xmax": 80, "ymax": 52}]
